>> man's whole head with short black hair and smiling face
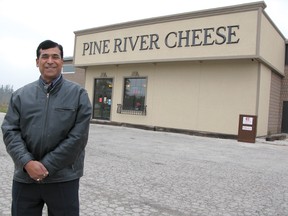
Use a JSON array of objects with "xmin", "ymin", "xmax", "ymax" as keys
[{"xmin": 36, "ymin": 40, "xmax": 63, "ymax": 83}]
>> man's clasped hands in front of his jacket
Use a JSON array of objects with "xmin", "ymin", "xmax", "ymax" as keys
[{"xmin": 24, "ymin": 161, "xmax": 49, "ymax": 182}]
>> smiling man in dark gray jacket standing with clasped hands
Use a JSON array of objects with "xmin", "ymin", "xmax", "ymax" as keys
[{"xmin": 1, "ymin": 40, "xmax": 91, "ymax": 216}]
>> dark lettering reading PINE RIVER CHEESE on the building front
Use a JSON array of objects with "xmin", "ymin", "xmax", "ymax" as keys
[{"xmin": 82, "ymin": 25, "xmax": 240, "ymax": 56}]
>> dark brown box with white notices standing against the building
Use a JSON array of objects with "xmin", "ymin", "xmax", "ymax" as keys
[{"xmin": 238, "ymin": 114, "xmax": 257, "ymax": 143}]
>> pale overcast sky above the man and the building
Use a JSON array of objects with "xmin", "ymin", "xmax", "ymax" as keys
[{"xmin": 0, "ymin": 0, "xmax": 288, "ymax": 90}]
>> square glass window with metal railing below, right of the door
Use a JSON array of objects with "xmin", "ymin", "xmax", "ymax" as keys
[{"xmin": 123, "ymin": 78, "xmax": 147, "ymax": 111}]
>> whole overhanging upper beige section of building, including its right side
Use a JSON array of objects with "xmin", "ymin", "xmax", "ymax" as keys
[{"xmin": 74, "ymin": 2, "xmax": 285, "ymax": 75}]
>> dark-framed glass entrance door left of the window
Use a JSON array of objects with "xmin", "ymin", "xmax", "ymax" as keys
[{"xmin": 93, "ymin": 78, "xmax": 113, "ymax": 120}]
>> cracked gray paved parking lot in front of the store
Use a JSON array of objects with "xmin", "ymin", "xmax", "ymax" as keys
[{"xmin": 0, "ymin": 113, "xmax": 288, "ymax": 216}]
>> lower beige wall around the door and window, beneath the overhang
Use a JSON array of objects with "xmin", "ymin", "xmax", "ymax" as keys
[{"xmin": 86, "ymin": 60, "xmax": 270, "ymax": 135}]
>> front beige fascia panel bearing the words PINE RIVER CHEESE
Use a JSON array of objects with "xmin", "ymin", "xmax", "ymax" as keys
[{"xmin": 75, "ymin": 11, "xmax": 258, "ymax": 66}]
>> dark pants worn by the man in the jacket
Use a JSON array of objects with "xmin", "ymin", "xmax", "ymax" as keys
[{"xmin": 12, "ymin": 179, "xmax": 79, "ymax": 216}]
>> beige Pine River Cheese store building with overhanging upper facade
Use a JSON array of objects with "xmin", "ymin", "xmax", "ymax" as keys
[{"xmin": 68, "ymin": 2, "xmax": 288, "ymax": 137}]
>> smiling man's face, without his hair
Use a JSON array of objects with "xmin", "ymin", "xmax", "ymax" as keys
[{"xmin": 36, "ymin": 47, "xmax": 63, "ymax": 83}]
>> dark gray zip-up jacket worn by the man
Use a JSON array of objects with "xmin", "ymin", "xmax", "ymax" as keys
[{"xmin": 1, "ymin": 78, "xmax": 91, "ymax": 183}]
